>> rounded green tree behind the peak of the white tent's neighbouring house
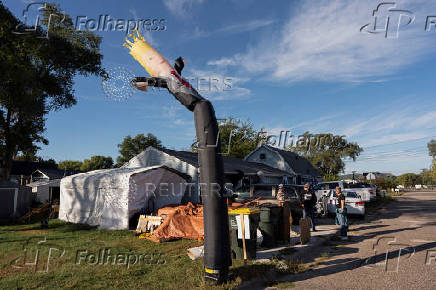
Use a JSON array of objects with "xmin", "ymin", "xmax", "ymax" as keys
[{"xmin": 117, "ymin": 133, "xmax": 163, "ymax": 166}]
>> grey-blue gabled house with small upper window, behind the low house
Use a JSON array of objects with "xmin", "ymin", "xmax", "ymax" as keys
[{"xmin": 245, "ymin": 144, "xmax": 322, "ymax": 184}]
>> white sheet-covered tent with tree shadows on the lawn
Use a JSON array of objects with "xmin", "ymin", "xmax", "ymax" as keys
[{"xmin": 59, "ymin": 166, "xmax": 189, "ymax": 229}]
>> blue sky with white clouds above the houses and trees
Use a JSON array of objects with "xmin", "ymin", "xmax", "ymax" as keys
[{"xmin": 3, "ymin": 0, "xmax": 436, "ymax": 174}]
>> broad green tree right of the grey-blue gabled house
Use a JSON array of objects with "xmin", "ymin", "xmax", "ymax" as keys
[{"xmin": 286, "ymin": 132, "xmax": 363, "ymax": 178}]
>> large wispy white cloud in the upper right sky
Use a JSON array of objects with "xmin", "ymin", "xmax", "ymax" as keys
[{"xmin": 209, "ymin": 0, "xmax": 436, "ymax": 82}]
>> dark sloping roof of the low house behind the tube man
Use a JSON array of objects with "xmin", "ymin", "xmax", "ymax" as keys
[{"xmin": 159, "ymin": 148, "xmax": 290, "ymax": 176}]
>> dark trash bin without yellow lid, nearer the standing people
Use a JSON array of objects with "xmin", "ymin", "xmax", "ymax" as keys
[{"xmin": 259, "ymin": 204, "xmax": 282, "ymax": 248}]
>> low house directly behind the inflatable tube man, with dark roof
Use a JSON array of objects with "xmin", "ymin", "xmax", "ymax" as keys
[{"xmin": 123, "ymin": 146, "xmax": 292, "ymax": 202}]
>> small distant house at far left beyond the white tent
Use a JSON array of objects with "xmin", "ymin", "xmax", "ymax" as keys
[{"xmin": 26, "ymin": 168, "xmax": 80, "ymax": 203}]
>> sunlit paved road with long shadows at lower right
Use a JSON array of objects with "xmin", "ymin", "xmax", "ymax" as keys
[{"xmin": 286, "ymin": 192, "xmax": 436, "ymax": 289}]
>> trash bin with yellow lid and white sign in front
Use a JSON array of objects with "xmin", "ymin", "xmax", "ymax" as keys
[{"xmin": 229, "ymin": 208, "xmax": 259, "ymax": 260}]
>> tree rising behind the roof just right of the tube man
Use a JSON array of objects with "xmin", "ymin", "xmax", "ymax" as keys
[{"xmin": 191, "ymin": 117, "xmax": 266, "ymax": 158}]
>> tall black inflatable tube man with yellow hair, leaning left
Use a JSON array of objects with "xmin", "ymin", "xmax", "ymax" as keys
[{"xmin": 124, "ymin": 31, "xmax": 232, "ymax": 282}]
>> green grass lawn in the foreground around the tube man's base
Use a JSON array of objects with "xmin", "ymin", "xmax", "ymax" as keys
[{"xmin": 0, "ymin": 220, "xmax": 300, "ymax": 289}]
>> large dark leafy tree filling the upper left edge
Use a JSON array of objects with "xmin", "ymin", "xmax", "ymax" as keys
[{"xmin": 0, "ymin": 2, "xmax": 103, "ymax": 179}]
